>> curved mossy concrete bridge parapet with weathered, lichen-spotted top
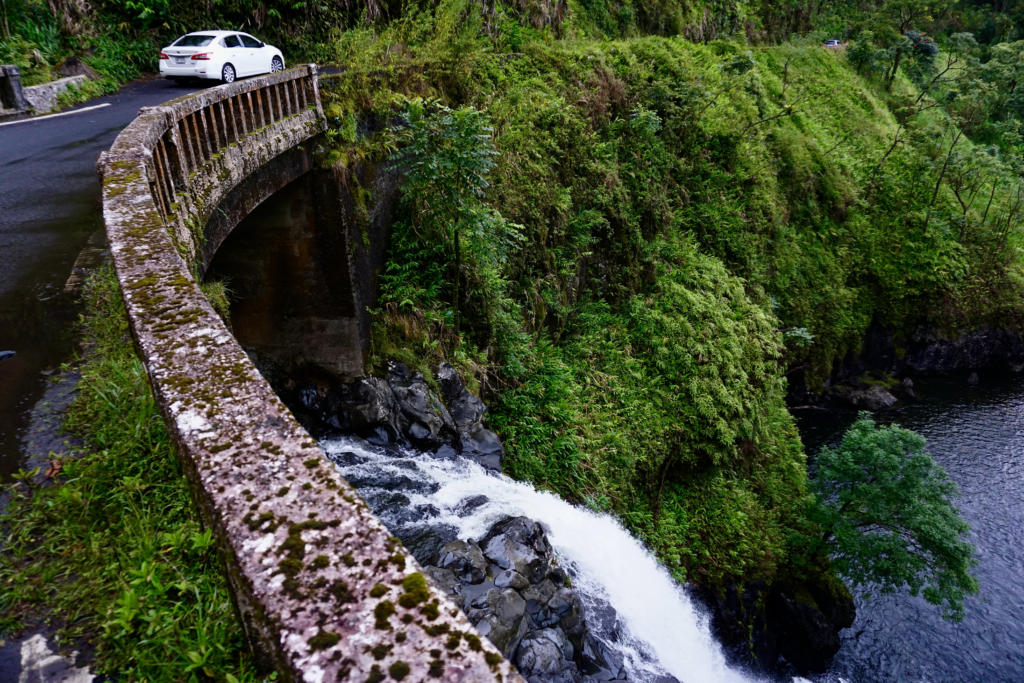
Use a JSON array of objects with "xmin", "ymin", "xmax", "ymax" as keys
[{"xmin": 98, "ymin": 66, "xmax": 518, "ymax": 681}]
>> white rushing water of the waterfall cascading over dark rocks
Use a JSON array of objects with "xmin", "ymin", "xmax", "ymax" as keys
[{"xmin": 323, "ymin": 437, "xmax": 751, "ymax": 683}]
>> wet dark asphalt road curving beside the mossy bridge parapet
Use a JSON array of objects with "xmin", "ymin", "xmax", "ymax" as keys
[{"xmin": 0, "ymin": 74, "xmax": 202, "ymax": 481}]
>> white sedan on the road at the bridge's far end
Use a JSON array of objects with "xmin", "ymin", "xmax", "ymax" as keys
[{"xmin": 160, "ymin": 31, "xmax": 285, "ymax": 83}]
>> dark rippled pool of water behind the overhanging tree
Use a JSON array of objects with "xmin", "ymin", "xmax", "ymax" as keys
[{"xmin": 800, "ymin": 376, "xmax": 1024, "ymax": 682}]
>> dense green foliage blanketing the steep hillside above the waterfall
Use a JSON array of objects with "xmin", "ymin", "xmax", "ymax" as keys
[{"xmin": 325, "ymin": 3, "xmax": 1020, "ymax": 586}]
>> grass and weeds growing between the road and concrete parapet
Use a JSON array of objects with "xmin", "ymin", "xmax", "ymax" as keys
[{"xmin": 0, "ymin": 269, "xmax": 264, "ymax": 681}]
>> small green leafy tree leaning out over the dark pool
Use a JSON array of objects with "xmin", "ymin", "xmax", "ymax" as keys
[{"xmin": 811, "ymin": 413, "xmax": 978, "ymax": 621}]
